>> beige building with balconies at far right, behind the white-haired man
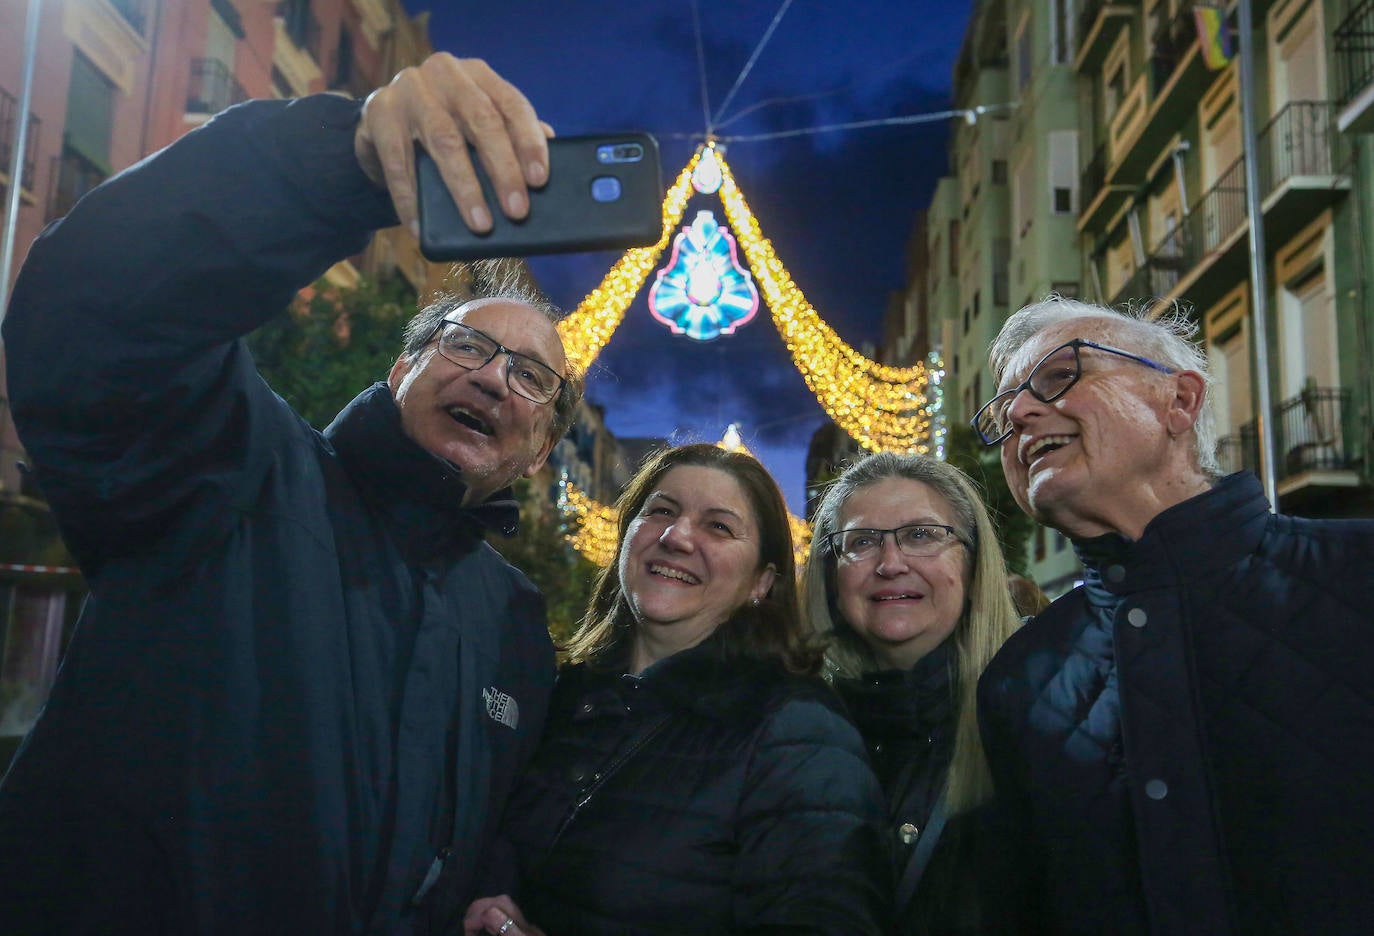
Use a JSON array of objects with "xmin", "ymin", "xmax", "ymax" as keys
[{"xmin": 1074, "ymin": 0, "xmax": 1374, "ymax": 515}]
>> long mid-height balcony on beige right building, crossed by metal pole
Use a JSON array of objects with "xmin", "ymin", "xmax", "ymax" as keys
[{"xmin": 1112, "ymin": 102, "xmax": 1351, "ymax": 309}]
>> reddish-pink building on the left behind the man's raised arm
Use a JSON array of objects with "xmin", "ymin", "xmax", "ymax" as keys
[{"xmin": 0, "ymin": 0, "xmax": 442, "ymax": 770}]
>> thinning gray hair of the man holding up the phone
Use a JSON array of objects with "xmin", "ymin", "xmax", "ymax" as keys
[{"xmin": 401, "ymin": 260, "xmax": 584, "ymax": 443}]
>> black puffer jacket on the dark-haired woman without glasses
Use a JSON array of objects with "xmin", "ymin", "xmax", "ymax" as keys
[{"xmin": 506, "ymin": 640, "xmax": 890, "ymax": 936}]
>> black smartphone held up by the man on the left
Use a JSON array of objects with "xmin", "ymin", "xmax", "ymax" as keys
[{"xmin": 415, "ymin": 132, "xmax": 664, "ymax": 261}]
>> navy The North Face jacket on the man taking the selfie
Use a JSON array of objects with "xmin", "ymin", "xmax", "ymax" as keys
[{"xmin": 0, "ymin": 96, "xmax": 554, "ymax": 936}]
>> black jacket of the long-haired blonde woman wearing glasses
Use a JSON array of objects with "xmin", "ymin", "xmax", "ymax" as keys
[{"xmin": 834, "ymin": 640, "xmax": 999, "ymax": 936}]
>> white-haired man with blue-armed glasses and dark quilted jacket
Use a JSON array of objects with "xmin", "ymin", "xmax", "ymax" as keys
[{"xmin": 973, "ymin": 298, "xmax": 1374, "ymax": 935}]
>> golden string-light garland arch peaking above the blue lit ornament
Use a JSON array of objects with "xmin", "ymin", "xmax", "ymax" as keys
[{"xmin": 559, "ymin": 143, "xmax": 938, "ymax": 452}]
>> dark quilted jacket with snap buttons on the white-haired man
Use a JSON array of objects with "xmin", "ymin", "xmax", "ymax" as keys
[{"xmin": 978, "ymin": 474, "xmax": 1374, "ymax": 936}]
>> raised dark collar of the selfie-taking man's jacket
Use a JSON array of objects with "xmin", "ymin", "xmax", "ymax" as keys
[{"xmin": 324, "ymin": 382, "xmax": 519, "ymax": 558}]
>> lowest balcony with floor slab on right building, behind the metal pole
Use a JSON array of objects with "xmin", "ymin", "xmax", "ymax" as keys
[{"xmin": 1217, "ymin": 386, "xmax": 1360, "ymax": 510}]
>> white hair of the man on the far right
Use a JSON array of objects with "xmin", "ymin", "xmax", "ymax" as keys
[{"xmin": 988, "ymin": 296, "xmax": 1221, "ymax": 478}]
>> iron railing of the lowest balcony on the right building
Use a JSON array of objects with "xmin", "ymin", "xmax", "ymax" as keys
[{"xmin": 1217, "ymin": 386, "xmax": 1355, "ymax": 481}]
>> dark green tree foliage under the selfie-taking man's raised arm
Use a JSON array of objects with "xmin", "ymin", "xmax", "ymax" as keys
[{"xmin": 249, "ymin": 276, "xmax": 415, "ymax": 429}]
